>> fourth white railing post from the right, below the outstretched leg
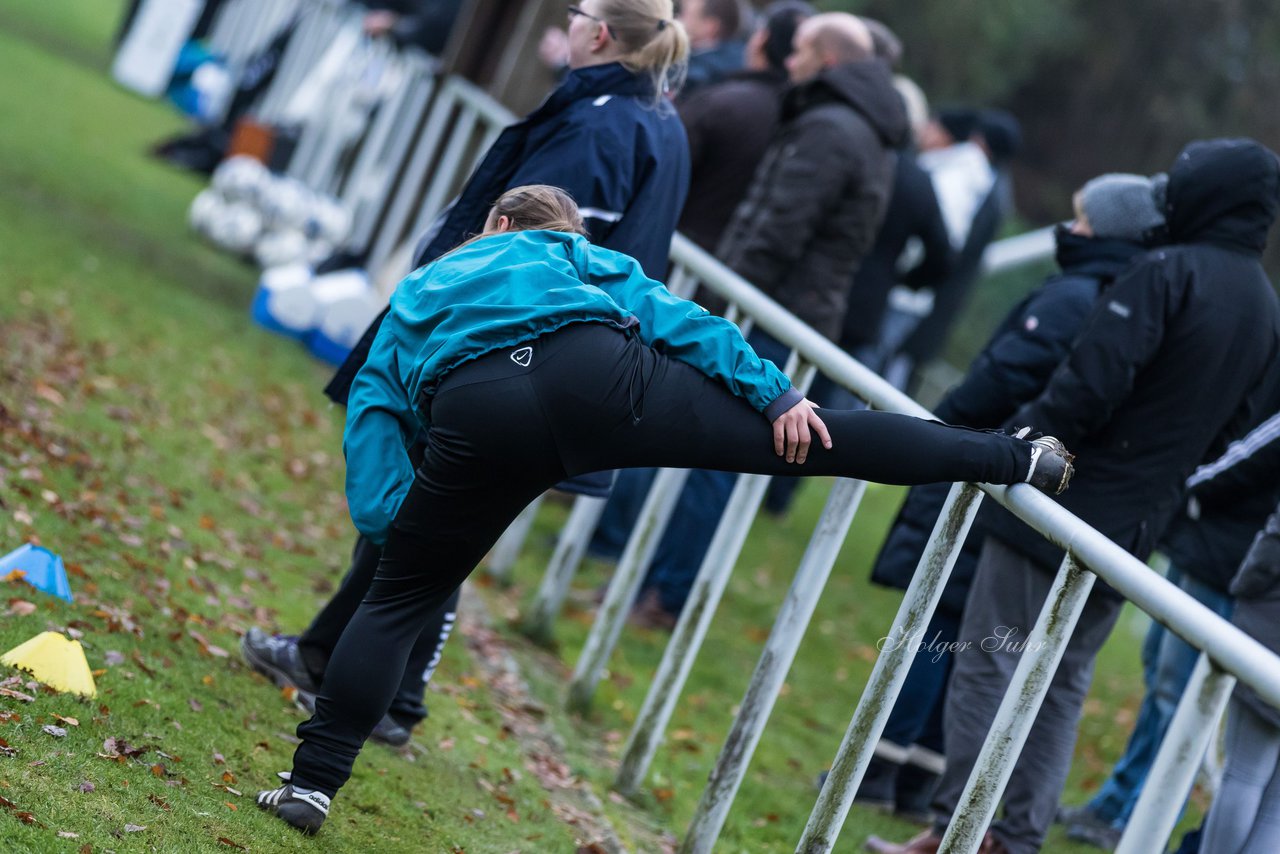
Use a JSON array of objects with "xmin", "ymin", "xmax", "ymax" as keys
[{"xmin": 680, "ymin": 478, "xmax": 867, "ymax": 854}]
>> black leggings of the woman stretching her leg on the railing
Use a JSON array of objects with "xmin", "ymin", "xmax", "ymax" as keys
[{"xmin": 293, "ymin": 324, "xmax": 1030, "ymax": 796}]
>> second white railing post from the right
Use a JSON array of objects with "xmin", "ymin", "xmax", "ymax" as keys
[{"xmin": 940, "ymin": 553, "xmax": 1097, "ymax": 854}]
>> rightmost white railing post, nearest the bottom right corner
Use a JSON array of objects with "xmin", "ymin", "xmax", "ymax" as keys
[{"xmin": 1116, "ymin": 653, "xmax": 1235, "ymax": 854}]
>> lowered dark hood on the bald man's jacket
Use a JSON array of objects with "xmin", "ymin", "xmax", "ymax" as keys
[{"xmin": 782, "ymin": 59, "xmax": 911, "ymax": 149}]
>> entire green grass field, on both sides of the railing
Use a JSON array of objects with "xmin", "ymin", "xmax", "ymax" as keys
[{"xmin": 0, "ymin": 0, "xmax": 1196, "ymax": 853}]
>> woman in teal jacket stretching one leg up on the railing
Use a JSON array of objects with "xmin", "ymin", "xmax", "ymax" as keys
[{"xmin": 257, "ymin": 186, "xmax": 1071, "ymax": 832}]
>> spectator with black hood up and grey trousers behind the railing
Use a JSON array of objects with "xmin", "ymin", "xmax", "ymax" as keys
[{"xmin": 879, "ymin": 140, "xmax": 1280, "ymax": 854}]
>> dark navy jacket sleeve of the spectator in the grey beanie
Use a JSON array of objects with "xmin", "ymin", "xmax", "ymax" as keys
[{"xmin": 938, "ymin": 280, "xmax": 1097, "ymax": 429}]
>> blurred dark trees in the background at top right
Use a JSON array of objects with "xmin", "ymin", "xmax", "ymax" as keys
[{"xmin": 818, "ymin": 0, "xmax": 1280, "ymax": 261}]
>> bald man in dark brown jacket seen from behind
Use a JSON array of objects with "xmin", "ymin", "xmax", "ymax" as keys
[{"xmin": 718, "ymin": 13, "xmax": 909, "ymax": 338}]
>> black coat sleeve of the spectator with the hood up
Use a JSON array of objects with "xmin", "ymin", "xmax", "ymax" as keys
[{"xmin": 1011, "ymin": 259, "xmax": 1175, "ymax": 448}]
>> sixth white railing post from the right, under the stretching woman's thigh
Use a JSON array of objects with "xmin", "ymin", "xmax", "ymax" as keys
[{"xmin": 567, "ymin": 469, "xmax": 689, "ymax": 712}]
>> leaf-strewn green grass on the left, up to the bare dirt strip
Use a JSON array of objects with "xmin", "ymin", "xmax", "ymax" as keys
[{"xmin": 0, "ymin": 1, "xmax": 581, "ymax": 851}]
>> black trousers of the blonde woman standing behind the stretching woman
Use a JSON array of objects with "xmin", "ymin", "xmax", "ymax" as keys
[{"xmin": 298, "ymin": 536, "xmax": 458, "ymax": 730}]
